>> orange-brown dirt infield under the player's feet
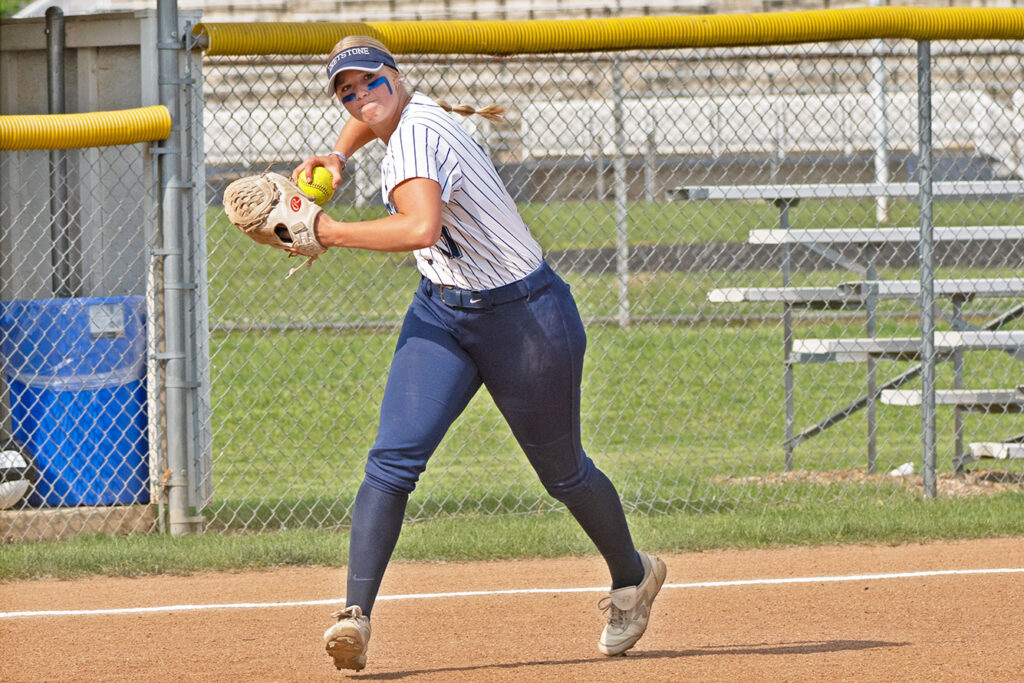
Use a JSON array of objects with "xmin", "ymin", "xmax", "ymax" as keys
[{"xmin": 0, "ymin": 538, "xmax": 1024, "ymax": 682}]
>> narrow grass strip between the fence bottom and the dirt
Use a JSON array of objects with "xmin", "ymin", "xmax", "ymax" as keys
[{"xmin": 0, "ymin": 494, "xmax": 1024, "ymax": 581}]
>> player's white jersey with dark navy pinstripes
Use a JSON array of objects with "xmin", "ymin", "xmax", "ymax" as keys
[{"xmin": 381, "ymin": 92, "xmax": 542, "ymax": 290}]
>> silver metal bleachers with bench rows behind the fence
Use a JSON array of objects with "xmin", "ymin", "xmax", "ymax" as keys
[{"xmin": 684, "ymin": 180, "xmax": 1024, "ymax": 472}]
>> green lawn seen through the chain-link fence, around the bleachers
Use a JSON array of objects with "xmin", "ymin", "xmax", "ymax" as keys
[{"xmin": 195, "ymin": 192, "xmax": 1019, "ymax": 530}]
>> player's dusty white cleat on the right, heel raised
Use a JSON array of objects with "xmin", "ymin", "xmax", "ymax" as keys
[{"xmin": 597, "ymin": 553, "xmax": 667, "ymax": 656}]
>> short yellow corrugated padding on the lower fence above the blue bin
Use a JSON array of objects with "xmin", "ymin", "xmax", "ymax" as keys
[{"xmin": 0, "ymin": 104, "xmax": 171, "ymax": 150}]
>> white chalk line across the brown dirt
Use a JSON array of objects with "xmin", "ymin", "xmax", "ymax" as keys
[{"xmin": 0, "ymin": 567, "xmax": 1024, "ymax": 618}]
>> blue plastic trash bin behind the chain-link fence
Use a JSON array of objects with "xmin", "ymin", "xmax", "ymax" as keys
[{"xmin": 0, "ymin": 296, "xmax": 150, "ymax": 507}]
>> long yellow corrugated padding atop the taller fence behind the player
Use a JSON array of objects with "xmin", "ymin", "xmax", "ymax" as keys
[{"xmin": 193, "ymin": 7, "xmax": 1024, "ymax": 55}]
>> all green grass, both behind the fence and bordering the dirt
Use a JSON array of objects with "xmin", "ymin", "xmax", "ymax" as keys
[{"xmin": 8, "ymin": 194, "xmax": 1024, "ymax": 580}]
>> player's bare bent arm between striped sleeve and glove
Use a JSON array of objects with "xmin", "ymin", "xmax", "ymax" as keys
[{"xmin": 315, "ymin": 178, "xmax": 441, "ymax": 252}]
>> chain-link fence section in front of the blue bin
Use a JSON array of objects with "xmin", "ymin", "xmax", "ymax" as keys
[{"xmin": 0, "ymin": 144, "xmax": 159, "ymax": 538}]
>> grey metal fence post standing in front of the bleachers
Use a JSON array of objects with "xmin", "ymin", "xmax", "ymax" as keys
[{"xmin": 918, "ymin": 40, "xmax": 936, "ymax": 498}]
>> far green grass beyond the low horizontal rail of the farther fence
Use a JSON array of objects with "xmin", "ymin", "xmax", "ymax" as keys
[{"xmin": 208, "ymin": 194, "xmax": 1020, "ymax": 326}]
